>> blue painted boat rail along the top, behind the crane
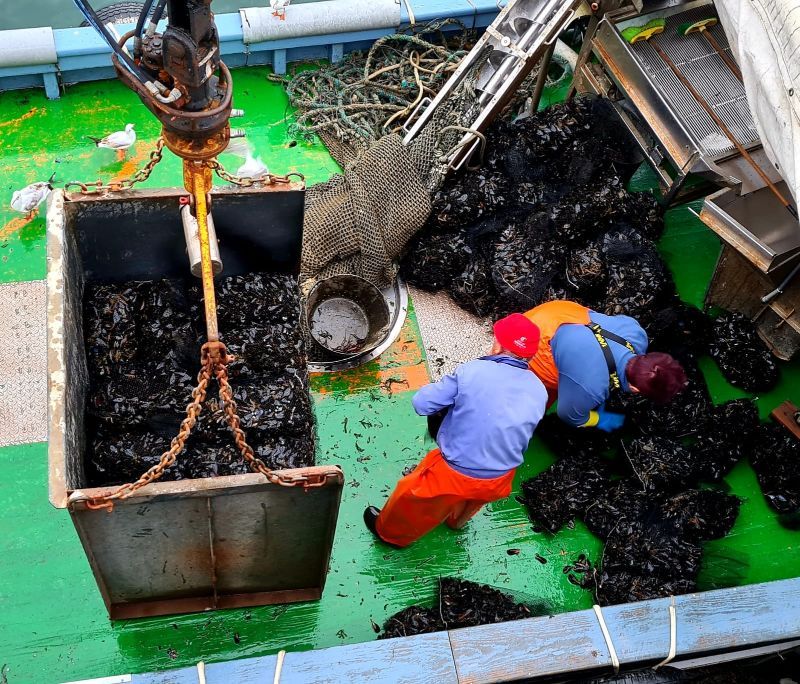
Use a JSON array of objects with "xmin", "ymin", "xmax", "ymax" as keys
[{"xmin": 0, "ymin": 0, "xmax": 499, "ymax": 97}]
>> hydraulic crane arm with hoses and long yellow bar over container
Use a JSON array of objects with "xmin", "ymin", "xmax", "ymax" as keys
[{"xmin": 75, "ymin": 0, "xmax": 234, "ymax": 362}]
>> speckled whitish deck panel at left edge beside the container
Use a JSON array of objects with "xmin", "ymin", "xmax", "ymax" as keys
[{"xmin": 0, "ymin": 280, "xmax": 47, "ymax": 446}]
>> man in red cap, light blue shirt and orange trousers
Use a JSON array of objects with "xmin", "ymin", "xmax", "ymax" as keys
[{"xmin": 364, "ymin": 314, "xmax": 547, "ymax": 547}]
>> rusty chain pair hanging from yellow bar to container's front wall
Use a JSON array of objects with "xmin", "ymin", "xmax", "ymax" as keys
[{"xmin": 86, "ymin": 342, "xmax": 325, "ymax": 513}]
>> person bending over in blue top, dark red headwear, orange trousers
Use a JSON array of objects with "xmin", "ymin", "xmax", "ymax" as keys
[{"xmin": 524, "ymin": 300, "xmax": 687, "ymax": 432}]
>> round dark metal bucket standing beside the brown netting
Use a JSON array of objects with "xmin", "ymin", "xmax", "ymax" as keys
[{"xmin": 305, "ymin": 274, "xmax": 390, "ymax": 357}]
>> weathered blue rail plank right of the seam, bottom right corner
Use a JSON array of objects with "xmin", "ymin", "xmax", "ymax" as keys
[{"xmin": 450, "ymin": 579, "xmax": 800, "ymax": 684}]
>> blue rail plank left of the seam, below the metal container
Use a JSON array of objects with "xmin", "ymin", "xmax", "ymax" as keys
[{"xmin": 133, "ymin": 632, "xmax": 458, "ymax": 684}]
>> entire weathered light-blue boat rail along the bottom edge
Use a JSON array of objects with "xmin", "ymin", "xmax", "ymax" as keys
[{"xmin": 83, "ymin": 578, "xmax": 800, "ymax": 684}]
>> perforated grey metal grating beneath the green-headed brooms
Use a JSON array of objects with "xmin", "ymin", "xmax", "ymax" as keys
[{"xmin": 630, "ymin": 6, "xmax": 759, "ymax": 159}]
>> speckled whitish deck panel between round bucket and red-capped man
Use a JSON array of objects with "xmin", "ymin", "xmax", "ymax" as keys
[{"xmin": 409, "ymin": 287, "xmax": 493, "ymax": 381}]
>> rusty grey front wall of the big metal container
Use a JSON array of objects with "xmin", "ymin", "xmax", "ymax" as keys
[{"xmin": 69, "ymin": 466, "xmax": 344, "ymax": 619}]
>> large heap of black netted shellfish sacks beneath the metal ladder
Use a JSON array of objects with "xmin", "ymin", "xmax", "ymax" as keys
[{"xmin": 401, "ymin": 98, "xmax": 674, "ymax": 317}]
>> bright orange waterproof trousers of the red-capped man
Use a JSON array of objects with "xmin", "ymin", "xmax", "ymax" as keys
[{"xmin": 376, "ymin": 449, "xmax": 514, "ymax": 546}]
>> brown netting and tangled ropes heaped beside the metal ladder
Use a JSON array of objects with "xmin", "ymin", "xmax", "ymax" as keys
[{"xmin": 288, "ymin": 23, "xmax": 506, "ymax": 292}]
